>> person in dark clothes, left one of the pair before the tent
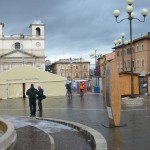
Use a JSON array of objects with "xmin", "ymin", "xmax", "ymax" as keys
[{"xmin": 26, "ymin": 84, "xmax": 38, "ymax": 117}]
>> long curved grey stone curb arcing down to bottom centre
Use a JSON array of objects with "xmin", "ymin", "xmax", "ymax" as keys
[{"xmin": 36, "ymin": 117, "xmax": 107, "ymax": 150}]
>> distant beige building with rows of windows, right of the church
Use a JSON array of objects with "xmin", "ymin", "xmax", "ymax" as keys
[{"xmin": 49, "ymin": 58, "xmax": 90, "ymax": 81}]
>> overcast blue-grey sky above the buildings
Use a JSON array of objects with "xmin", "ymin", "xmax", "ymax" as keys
[{"xmin": 0, "ymin": 0, "xmax": 150, "ymax": 63}]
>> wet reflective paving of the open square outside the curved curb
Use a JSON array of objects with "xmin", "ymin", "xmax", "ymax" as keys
[{"xmin": 0, "ymin": 94, "xmax": 150, "ymax": 150}]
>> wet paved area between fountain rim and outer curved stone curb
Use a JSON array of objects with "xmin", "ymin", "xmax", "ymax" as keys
[{"xmin": 3, "ymin": 116, "xmax": 92, "ymax": 150}]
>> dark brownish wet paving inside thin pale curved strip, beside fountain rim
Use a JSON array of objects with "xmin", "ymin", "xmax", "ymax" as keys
[{"xmin": 14, "ymin": 126, "xmax": 51, "ymax": 150}]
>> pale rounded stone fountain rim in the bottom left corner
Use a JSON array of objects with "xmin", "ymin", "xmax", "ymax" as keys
[{"xmin": 0, "ymin": 118, "xmax": 17, "ymax": 150}]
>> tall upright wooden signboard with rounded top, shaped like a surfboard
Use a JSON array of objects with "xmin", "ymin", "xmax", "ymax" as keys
[{"xmin": 105, "ymin": 61, "xmax": 121, "ymax": 126}]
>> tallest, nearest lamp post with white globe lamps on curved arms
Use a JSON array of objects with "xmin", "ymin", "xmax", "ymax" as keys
[{"xmin": 113, "ymin": 0, "xmax": 148, "ymax": 98}]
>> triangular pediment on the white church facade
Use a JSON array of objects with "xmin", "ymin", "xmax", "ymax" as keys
[{"xmin": 1, "ymin": 50, "xmax": 37, "ymax": 58}]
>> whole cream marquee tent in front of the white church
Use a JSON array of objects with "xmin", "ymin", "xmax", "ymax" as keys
[{"xmin": 0, "ymin": 65, "xmax": 66, "ymax": 99}]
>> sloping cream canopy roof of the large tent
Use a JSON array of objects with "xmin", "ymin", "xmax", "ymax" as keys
[{"xmin": 0, "ymin": 65, "xmax": 66, "ymax": 84}]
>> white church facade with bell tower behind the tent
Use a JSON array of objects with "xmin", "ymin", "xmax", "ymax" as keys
[{"xmin": 0, "ymin": 21, "xmax": 45, "ymax": 73}]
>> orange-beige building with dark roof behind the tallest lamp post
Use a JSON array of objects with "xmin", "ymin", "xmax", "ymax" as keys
[{"xmin": 113, "ymin": 32, "xmax": 150, "ymax": 76}]
